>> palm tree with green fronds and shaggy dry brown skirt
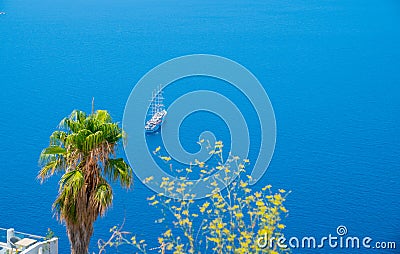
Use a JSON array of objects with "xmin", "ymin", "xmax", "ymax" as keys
[{"xmin": 38, "ymin": 110, "xmax": 133, "ymax": 254}]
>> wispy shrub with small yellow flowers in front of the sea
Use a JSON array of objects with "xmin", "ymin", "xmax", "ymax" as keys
[{"xmin": 97, "ymin": 141, "xmax": 290, "ymax": 254}]
